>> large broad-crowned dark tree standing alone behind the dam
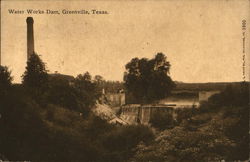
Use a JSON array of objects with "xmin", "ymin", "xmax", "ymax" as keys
[{"xmin": 124, "ymin": 53, "xmax": 175, "ymax": 103}]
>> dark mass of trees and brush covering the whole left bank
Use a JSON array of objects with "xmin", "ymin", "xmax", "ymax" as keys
[{"xmin": 0, "ymin": 54, "xmax": 154, "ymax": 162}]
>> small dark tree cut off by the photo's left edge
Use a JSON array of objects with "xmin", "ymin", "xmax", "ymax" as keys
[{"xmin": 0, "ymin": 66, "xmax": 13, "ymax": 92}]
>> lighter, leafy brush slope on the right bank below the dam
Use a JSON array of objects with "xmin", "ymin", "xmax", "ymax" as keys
[{"xmin": 135, "ymin": 83, "xmax": 249, "ymax": 162}]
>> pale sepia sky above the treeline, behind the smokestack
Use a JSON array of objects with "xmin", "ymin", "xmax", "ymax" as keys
[{"xmin": 1, "ymin": 0, "xmax": 250, "ymax": 83}]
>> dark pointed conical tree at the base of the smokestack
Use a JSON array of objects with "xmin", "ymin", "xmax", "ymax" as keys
[{"xmin": 22, "ymin": 53, "xmax": 48, "ymax": 89}]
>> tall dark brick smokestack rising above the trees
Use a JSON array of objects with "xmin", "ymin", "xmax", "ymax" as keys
[{"xmin": 26, "ymin": 17, "xmax": 35, "ymax": 59}]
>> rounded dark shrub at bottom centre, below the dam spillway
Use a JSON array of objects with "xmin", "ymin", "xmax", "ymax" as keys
[{"xmin": 102, "ymin": 125, "xmax": 154, "ymax": 161}]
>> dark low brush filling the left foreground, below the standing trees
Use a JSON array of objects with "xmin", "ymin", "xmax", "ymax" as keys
[{"xmin": 0, "ymin": 88, "xmax": 154, "ymax": 161}]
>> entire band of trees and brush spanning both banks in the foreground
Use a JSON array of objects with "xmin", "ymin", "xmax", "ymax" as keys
[{"xmin": 0, "ymin": 55, "xmax": 249, "ymax": 162}]
